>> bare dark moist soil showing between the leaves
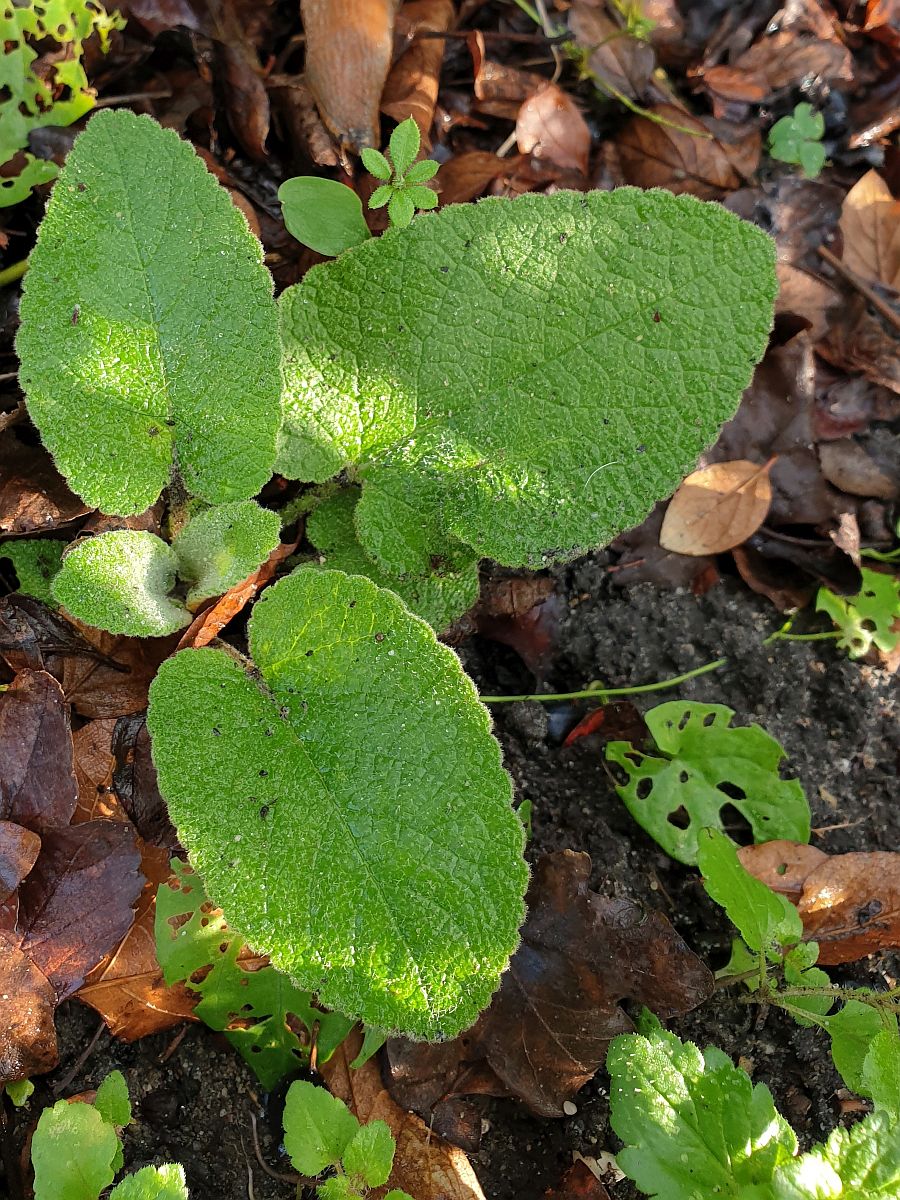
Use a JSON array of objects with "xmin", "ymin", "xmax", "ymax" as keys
[{"xmin": 24, "ymin": 554, "xmax": 900, "ymax": 1200}]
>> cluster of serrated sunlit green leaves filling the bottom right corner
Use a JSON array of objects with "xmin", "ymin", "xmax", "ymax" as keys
[{"xmin": 606, "ymin": 1010, "xmax": 900, "ymax": 1200}]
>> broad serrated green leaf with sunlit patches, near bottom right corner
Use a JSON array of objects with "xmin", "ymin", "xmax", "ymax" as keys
[{"xmin": 606, "ymin": 1014, "xmax": 797, "ymax": 1200}]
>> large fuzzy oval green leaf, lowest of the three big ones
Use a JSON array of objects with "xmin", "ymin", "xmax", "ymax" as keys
[{"xmin": 148, "ymin": 570, "xmax": 527, "ymax": 1038}]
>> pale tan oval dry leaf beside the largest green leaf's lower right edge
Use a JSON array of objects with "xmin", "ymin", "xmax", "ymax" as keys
[{"xmin": 659, "ymin": 458, "xmax": 772, "ymax": 557}]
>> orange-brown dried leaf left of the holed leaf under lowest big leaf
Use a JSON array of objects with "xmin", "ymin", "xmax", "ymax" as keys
[{"xmin": 77, "ymin": 842, "xmax": 200, "ymax": 1042}]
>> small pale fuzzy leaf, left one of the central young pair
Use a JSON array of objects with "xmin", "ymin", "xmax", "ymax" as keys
[{"xmin": 52, "ymin": 529, "xmax": 191, "ymax": 637}]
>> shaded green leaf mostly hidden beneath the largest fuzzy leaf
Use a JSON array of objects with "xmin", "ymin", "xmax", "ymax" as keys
[{"xmin": 306, "ymin": 487, "xmax": 479, "ymax": 634}]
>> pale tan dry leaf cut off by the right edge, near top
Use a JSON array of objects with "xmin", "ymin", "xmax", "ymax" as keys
[{"xmin": 840, "ymin": 170, "xmax": 900, "ymax": 290}]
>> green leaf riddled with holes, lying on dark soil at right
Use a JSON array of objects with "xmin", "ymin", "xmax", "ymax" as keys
[{"xmin": 606, "ymin": 700, "xmax": 810, "ymax": 865}]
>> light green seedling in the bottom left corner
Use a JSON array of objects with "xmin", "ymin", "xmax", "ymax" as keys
[{"xmin": 31, "ymin": 1070, "xmax": 187, "ymax": 1200}]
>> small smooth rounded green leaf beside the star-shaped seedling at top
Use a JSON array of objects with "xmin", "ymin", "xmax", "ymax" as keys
[{"xmin": 278, "ymin": 175, "xmax": 372, "ymax": 258}]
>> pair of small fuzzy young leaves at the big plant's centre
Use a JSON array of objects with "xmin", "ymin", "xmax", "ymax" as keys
[{"xmin": 50, "ymin": 500, "xmax": 281, "ymax": 637}]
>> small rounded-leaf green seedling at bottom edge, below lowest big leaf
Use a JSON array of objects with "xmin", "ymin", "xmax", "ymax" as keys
[{"xmin": 284, "ymin": 1080, "xmax": 412, "ymax": 1200}]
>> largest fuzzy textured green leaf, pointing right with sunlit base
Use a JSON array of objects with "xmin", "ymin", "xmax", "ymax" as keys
[{"xmin": 278, "ymin": 187, "xmax": 775, "ymax": 574}]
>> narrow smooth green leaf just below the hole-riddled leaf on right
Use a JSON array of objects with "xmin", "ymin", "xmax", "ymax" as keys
[{"xmin": 697, "ymin": 829, "xmax": 803, "ymax": 959}]
